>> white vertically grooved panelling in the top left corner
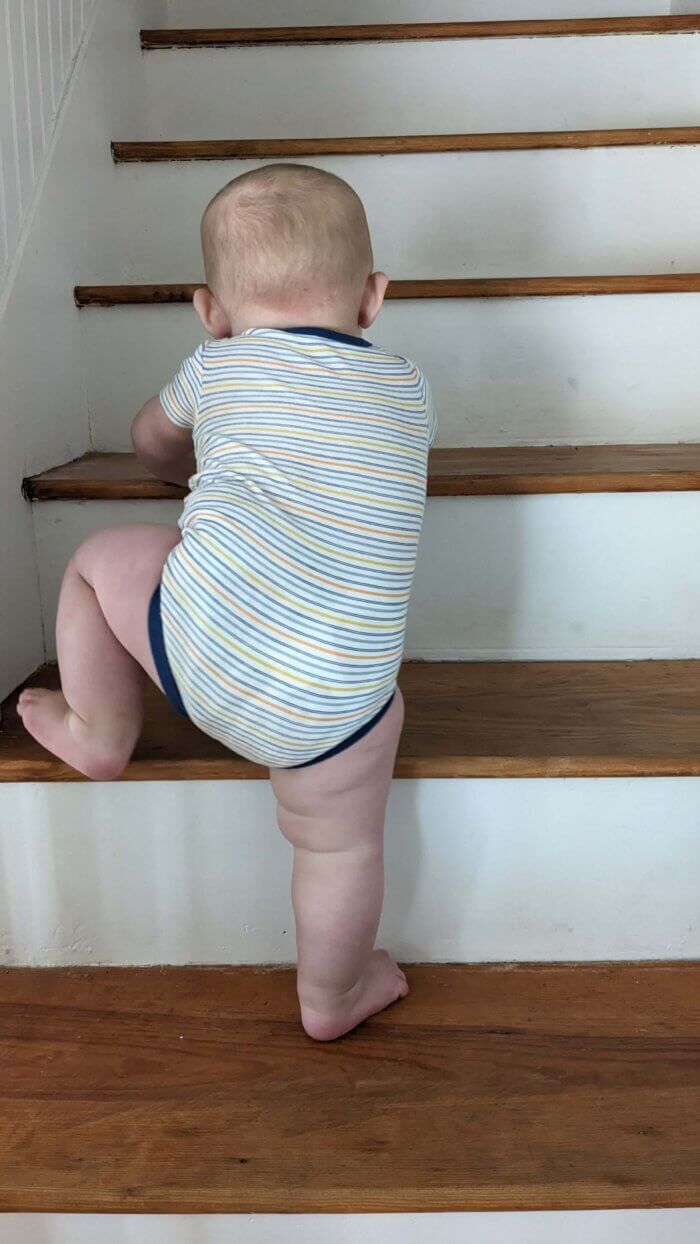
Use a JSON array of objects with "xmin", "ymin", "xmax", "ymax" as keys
[{"xmin": 0, "ymin": 0, "xmax": 94, "ymax": 292}]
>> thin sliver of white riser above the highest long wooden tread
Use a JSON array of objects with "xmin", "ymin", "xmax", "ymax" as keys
[{"xmin": 163, "ymin": 0, "xmax": 671, "ymax": 26}]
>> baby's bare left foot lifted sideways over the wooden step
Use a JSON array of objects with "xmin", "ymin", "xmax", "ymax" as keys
[{"xmin": 17, "ymin": 687, "xmax": 131, "ymax": 781}]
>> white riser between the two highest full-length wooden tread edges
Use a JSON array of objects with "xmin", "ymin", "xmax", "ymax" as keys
[{"xmin": 141, "ymin": 35, "xmax": 700, "ymax": 138}]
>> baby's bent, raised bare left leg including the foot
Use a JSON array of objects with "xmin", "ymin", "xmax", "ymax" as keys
[{"xmin": 17, "ymin": 524, "xmax": 180, "ymax": 781}]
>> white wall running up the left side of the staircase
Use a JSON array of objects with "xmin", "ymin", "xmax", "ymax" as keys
[{"xmin": 0, "ymin": 0, "xmax": 163, "ymax": 698}]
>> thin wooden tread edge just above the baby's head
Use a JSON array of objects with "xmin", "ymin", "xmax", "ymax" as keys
[{"xmin": 112, "ymin": 126, "xmax": 700, "ymax": 163}]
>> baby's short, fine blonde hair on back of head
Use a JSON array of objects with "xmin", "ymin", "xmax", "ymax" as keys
[{"xmin": 201, "ymin": 164, "xmax": 372, "ymax": 307}]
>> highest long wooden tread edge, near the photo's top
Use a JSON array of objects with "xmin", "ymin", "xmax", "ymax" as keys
[{"xmin": 140, "ymin": 14, "xmax": 700, "ymax": 50}]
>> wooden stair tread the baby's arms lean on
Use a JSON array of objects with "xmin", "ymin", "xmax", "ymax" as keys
[{"xmin": 24, "ymin": 443, "xmax": 700, "ymax": 501}]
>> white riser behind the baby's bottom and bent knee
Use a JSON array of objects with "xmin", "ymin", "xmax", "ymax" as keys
[{"xmin": 35, "ymin": 493, "xmax": 700, "ymax": 661}]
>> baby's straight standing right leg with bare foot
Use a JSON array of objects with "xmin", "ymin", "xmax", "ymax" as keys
[{"xmin": 270, "ymin": 692, "xmax": 408, "ymax": 1041}]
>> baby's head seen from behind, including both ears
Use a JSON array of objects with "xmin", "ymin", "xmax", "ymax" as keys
[{"xmin": 195, "ymin": 164, "xmax": 387, "ymax": 337}]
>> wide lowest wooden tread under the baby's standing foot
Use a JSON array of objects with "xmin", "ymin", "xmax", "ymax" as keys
[{"xmin": 0, "ymin": 963, "xmax": 700, "ymax": 1213}]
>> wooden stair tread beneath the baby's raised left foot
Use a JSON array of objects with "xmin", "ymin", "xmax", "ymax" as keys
[{"xmin": 6, "ymin": 661, "xmax": 700, "ymax": 781}]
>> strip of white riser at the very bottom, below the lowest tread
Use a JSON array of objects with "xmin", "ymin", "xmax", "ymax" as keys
[{"xmin": 0, "ymin": 1209, "xmax": 700, "ymax": 1244}]
